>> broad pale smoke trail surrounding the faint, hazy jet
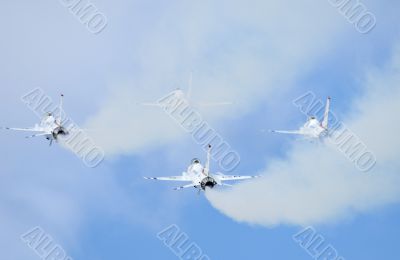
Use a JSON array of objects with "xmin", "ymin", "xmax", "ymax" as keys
[{"xmin": 87, "ymin": 0, "xmax": 342, "ymax": 154}]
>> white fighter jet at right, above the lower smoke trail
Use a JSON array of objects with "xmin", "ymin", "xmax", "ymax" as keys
[{"xmin": 270, "ymin": 97, "xmax": 331, "ymax": 139}]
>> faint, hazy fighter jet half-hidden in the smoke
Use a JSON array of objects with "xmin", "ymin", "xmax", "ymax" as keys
[{"xmin": 140, "ymin": 74, "xmax": 233, "ymax": 107}]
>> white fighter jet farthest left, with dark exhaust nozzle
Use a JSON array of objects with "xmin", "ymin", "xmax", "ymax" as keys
[{"xmin": 3, "ymin": 94, "xmax": 69, "ymax": 146}]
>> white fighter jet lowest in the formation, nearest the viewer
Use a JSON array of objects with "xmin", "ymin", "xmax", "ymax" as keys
[{"xmin": 144, "ymin": 145, "xmax": 260, "ymax": 192}]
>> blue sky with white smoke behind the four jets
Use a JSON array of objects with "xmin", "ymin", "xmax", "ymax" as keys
[{"xmin": 0, "ymin": 0, "xmax": 400, "ymax": 260}]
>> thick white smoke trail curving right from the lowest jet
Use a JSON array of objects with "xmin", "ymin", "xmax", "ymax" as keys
[{"xmin": 207, "ymin": 45, "xmax": 400, "ymax": 226}]
